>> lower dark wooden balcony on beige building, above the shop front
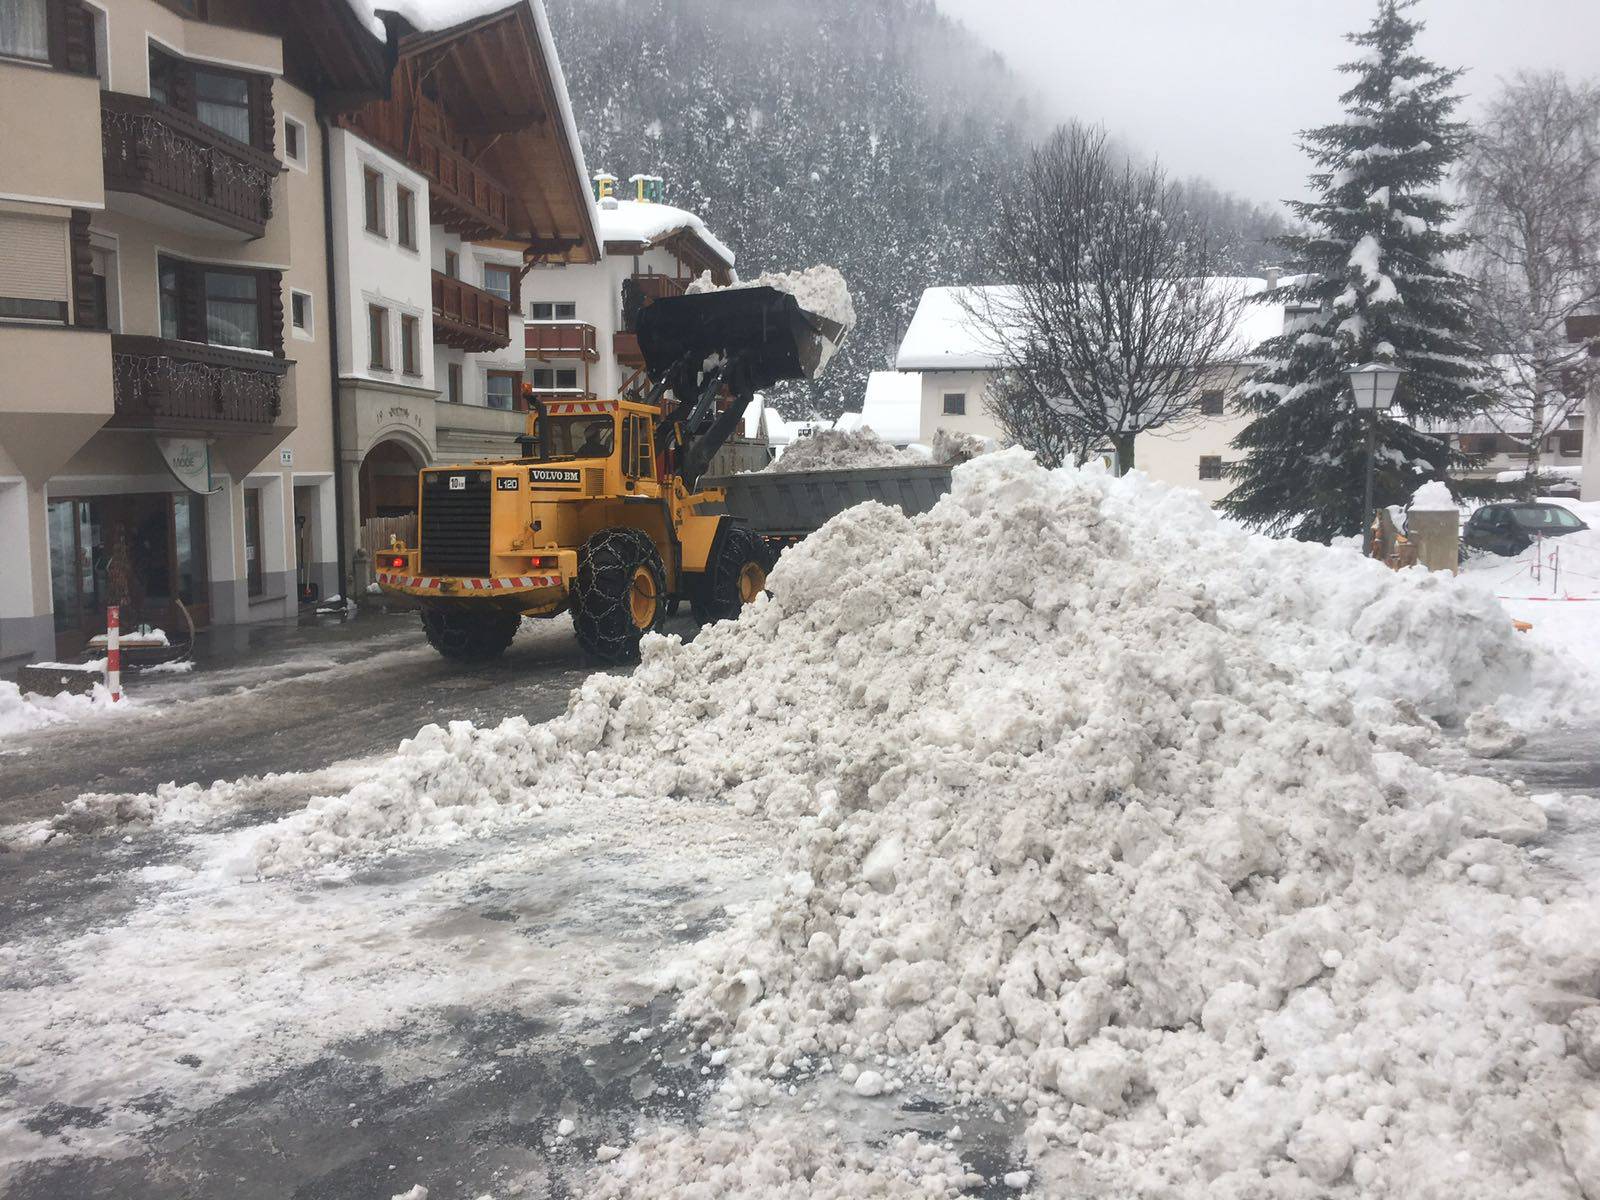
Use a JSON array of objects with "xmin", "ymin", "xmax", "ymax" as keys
[{"xmin": 110, "ymin": 334, "xmax": 290, "ymax": 434}]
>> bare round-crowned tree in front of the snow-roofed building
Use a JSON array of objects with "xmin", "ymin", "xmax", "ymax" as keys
[{"xmin": 965, "ymin": 125, "xmax": 1250, "ymax": 470}]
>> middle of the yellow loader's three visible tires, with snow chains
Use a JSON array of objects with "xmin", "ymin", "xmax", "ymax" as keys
[{"xmin": 573, "ymin": 528, "xmax": 667, "ymax": 662}]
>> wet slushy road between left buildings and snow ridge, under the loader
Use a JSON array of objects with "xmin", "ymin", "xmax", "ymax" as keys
[{"xmin": 0, "ymin": 613, "xmax": 646, "ymax": 826}]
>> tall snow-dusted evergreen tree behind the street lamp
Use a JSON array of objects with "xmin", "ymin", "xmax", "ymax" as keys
[{"xmin": 1224, "ymin": 0, "xmax": 1485, "ymax": 541}]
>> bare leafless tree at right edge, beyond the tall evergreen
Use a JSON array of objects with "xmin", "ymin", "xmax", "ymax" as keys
[{"xmin": 1461, "ymin": 72, "xmax": 1600, "ymax": 480}]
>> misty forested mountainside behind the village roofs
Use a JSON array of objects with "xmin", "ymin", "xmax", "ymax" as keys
[{"xmin": 546, "ymin": 0, "xmax": 1277, "ymax": 416}]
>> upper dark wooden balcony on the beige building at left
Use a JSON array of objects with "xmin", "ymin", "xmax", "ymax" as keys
[{"xmin": 101, "ymin": 91, "xmax": 280, "ymax": 240}]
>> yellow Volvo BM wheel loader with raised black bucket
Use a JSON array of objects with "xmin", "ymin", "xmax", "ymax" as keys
[{"xmin": 376, "ymin": 288, "xmax": 845, "ymax": 662}]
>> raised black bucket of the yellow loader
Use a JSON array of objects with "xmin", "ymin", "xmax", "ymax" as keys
[{"xmin": 638, "ymin": 286, "xmax": 845, "ymax": 390}]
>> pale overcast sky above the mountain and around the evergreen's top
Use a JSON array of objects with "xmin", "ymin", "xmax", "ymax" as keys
[{"xmin": 936, "ymin": 0, "xmax": 1600, "ymax": 200}]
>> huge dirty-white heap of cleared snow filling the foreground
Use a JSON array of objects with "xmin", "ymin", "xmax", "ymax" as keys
[{"xmin": 232, "ymin": 451, "xmax": 1600, "ymax": 1200}]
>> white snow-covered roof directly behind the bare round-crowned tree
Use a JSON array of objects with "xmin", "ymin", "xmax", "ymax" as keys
[{"xmin": 894, "ymin": 275, "xmax": 1283, "ymax": 371}]
